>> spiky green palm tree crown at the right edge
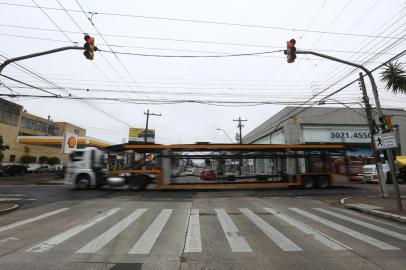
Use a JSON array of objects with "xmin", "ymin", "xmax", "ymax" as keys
[{"xmin": 381, "ymin": 62, "xmax": 406, "ymax": 94}]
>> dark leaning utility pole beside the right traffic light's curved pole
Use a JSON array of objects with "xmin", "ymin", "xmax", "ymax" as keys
[{"xmin": 359, "ymin": 72, "xmax": 388, "ymax": 198}]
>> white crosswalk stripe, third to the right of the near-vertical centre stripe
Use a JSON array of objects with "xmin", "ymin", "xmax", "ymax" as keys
[{"xmin": 264, "ymin": 208, "xmax": 351, "ymax": 250}]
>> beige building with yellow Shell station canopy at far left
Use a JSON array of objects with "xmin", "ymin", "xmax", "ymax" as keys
[{"xmin": 0, "ymin": 99, "xmax": 110, "ymax": 163}]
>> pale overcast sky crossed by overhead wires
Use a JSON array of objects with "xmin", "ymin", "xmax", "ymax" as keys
[{"xmin": 0, "ymin": 0, "xmax": 406, "ymax": 143}]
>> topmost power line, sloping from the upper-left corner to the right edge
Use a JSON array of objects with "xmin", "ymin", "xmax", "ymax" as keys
[{"xmin": 0, "ymin": 2, "xmax": 406, "ymax": 39}]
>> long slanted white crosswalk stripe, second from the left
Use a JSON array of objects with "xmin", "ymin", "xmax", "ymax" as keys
[{"xmin": 25, "ymin": 208, "xmax": 121, "ymax": 253}]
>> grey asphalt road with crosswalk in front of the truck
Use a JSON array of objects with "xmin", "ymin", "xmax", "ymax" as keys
[{"xmin": 0, "ymin": 184, "xmax": 406, "ymax": 270}]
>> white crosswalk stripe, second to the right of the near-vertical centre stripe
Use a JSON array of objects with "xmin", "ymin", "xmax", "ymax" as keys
[{"xmin": 240, "ymin": 208, "xmax": 303, "ymax": 251}]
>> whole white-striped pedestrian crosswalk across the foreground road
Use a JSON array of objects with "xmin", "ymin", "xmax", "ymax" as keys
[{"xmin": 0, "ymin": 207, "xmax": 406, "ymax": 255}]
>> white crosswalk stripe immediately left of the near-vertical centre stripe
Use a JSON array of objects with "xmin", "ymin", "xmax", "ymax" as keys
[{"xmin": 128, "ymin": 209, "xmax": 173, "ymax": 254}]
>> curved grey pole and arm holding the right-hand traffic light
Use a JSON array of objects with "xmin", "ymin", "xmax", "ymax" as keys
[{"xmin": 296, "ymin": 50, "xmax": 403, "ymax": 211}]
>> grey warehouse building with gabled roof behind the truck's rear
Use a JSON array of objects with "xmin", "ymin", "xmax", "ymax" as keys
[{"xmin": 243, "ymin": 107, "xmax": 406, "ymax": 174}]
